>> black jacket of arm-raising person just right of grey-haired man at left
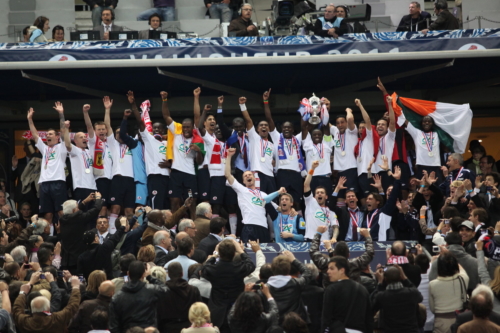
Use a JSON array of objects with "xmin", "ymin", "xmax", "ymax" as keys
[{"xmin": 78, "ymin": 226, "xmax": 125, "ymax": 281}]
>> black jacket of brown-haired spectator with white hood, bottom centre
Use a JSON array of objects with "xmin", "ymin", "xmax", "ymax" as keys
[{"xmin": 267, "ymin": 259, "xmax": 311, "ymax": 323}]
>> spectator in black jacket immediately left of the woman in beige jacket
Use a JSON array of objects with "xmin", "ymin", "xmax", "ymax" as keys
[{"xmin": 371, "ymin": 265, "xmax": 423, "ymax": 333}]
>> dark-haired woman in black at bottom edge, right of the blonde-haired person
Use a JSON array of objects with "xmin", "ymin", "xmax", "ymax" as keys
[{"xmin": 228, "ymin": 283, "xmax": 278, "ymax": 333}]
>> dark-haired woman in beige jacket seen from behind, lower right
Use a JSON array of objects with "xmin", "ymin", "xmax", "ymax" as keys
[{"xmin": 429, "ymin": 252, "xmax": 469, "ymax": 333}]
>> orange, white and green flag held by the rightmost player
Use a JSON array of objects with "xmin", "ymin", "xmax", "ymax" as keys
[{"xmin": 392, "ymin": 93, "xmax": 472, "ymax": 154}]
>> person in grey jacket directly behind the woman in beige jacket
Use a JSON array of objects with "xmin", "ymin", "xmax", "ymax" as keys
[{"xmin": 429, "ymin": 231, "xmax": 481, "ymax": 294}]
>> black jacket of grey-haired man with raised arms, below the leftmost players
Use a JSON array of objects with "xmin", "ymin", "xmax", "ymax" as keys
[{"xmin": 59, "ymin": 199, "xmax": 102, "ymax": 269}]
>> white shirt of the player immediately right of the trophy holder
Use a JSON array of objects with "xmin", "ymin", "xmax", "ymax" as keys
[{"xmin": 330, "ymin": 126, "xmax": 358, "ymax": 171}]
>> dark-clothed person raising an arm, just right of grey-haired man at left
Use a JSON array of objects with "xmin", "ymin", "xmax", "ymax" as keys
[{"xmin": 78, "ymin": 216, "xmax": 129, "ymax": 280}]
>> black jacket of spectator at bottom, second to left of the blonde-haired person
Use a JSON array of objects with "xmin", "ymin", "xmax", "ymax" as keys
[{"xmin": 109, "ymin": 277, "xmax": 168, "ymax": 333}]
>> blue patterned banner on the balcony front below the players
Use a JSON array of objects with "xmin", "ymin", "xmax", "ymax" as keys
[{"xmin": 246, "ymin": 241, "xmax": 417, "ymax": 270}]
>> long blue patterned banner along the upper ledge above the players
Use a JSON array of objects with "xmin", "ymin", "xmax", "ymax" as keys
[{"xmin": 0, "ymin": 29, "xmax": 500, "ymax": 65}]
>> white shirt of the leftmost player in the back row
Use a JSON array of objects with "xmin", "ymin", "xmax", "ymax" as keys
[{"xmin": 35, "ymin": 138, "xmax": 68, "ymax": 184}]
